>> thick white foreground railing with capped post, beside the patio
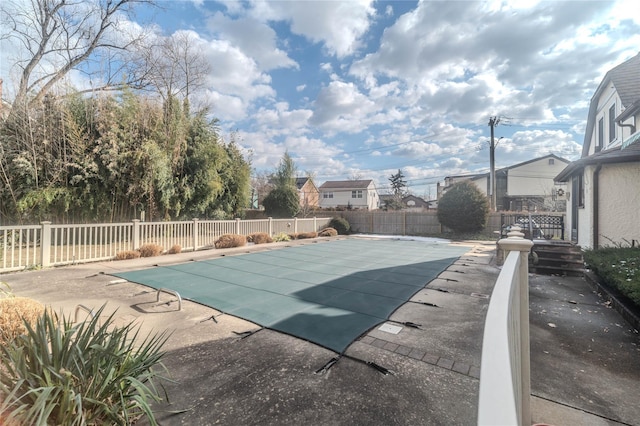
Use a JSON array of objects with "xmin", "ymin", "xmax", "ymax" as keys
[{"xmin": 478, "ymin": 227, "xmax": 533, "ymax": 425}]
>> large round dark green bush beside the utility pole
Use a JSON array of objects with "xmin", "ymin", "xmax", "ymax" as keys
[{"xmin": 438, "ymin": 181, "xmax": 489, "ymax": 233}]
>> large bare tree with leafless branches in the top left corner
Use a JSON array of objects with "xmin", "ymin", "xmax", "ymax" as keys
[{"xmin": 0, "ymin": 0, "xmax": 153, "ymax": 107}]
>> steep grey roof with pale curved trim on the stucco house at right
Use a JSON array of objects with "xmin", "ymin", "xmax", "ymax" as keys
[{"xmin": 582, "ymin": 53, "xmax": 640, "ymax": 157}]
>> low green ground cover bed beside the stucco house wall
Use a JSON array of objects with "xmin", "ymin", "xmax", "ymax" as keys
[{"xmin": 583, "ymin": 247, "xmax": 640, "ymax": 307}]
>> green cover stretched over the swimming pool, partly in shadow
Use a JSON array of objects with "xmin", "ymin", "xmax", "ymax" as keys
[{"xmin": 113, "ymin": 239, "xmax": 468, "ymax": 353}]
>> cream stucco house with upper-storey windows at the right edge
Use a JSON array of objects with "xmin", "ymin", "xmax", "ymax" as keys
[{"xmin": 556, "ymin": 54, "xmax": 640, "ymax": 248}]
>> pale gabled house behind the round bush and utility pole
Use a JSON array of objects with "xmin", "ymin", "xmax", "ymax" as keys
[{"xmin": 438, "ymin": 154, "xmax": 569, "ymax": 211}]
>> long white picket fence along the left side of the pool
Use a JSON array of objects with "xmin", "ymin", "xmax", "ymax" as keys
[{"xmin": 0, "ymin": 217, "xmax": 331, "ymax": 273}]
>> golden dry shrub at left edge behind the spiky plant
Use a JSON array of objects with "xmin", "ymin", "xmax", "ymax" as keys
[{"xmin": 0, "ymin": 297, "xmax": 44, "ymax": 346}]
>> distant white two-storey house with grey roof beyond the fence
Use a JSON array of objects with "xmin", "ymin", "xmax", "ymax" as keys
[{"xmin": 318, "ymin": 179, "xmax": 380, "ymax": 210}]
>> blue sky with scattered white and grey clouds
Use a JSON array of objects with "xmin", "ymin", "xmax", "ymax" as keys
[{"xmin": 1, "ymin": 0, "xmax": 640, "ymax": 199}]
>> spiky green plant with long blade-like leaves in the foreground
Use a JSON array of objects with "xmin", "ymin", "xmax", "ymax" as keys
[{"xmin": 0, "ymin": 306, "xmax": 168, "ymax": 425}]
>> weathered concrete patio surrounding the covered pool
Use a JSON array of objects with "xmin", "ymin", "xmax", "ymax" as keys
[{"xmin": 0, "ymin": 240, "xmax": 640, "ymax": 425}]
